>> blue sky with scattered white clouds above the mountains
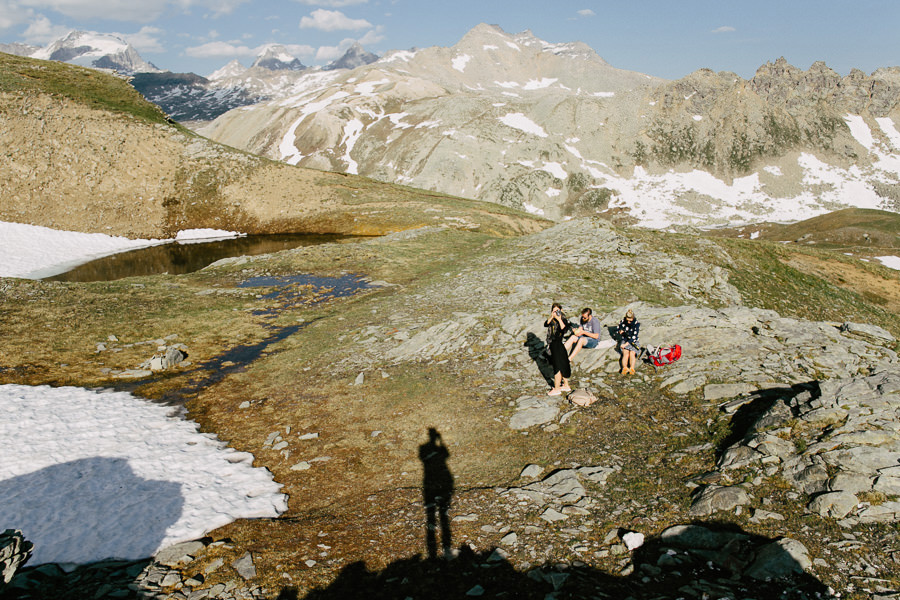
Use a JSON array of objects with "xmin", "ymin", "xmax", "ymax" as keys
[{"xmin": 0, "ymin": 0, "xmax": 900, "ymax": 79}]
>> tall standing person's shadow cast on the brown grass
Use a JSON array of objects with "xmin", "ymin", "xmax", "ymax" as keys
[{"xmin": 419, "ymin": 427, "xmax": 453, "ymax": 559}]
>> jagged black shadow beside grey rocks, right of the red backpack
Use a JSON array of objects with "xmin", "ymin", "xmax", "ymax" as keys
[{"xmin": 716, "ymin": 381, "xmax": 822, "ymax": 459}]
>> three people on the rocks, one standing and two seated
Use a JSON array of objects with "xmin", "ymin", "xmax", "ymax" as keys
[{"xmin": 544, "ymin": 302, "xmax": 641, "ymax": 396}]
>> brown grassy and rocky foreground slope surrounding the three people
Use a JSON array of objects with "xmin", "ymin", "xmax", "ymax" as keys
[{"xmin": 4, "ymin": 219, "xmax": 900, "ymax": 598}]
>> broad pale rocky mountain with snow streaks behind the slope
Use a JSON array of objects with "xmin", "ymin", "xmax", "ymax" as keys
[{"xmin": 200, "ymin": 24, "xmax": 900, "ymax": 227}]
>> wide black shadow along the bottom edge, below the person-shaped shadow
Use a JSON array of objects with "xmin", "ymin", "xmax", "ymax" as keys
[{"xmin": 288, "ymin": 522, "xmax": 834, "ymax": 600}]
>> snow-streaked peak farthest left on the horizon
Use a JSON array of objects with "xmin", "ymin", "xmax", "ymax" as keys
[{"xmin": 30, "ymin": 31, "xmax": 160, "ymax": 75}]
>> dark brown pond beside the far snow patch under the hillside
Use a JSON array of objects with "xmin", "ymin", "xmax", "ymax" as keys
[{"xmin": 48, "ymin": 234, "xmax": 355, "ymax": 281}]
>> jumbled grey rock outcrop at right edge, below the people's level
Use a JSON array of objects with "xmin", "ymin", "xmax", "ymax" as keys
[{"xmin": 718, "ymin": 364, "xmax": 900, "ymax": 524}]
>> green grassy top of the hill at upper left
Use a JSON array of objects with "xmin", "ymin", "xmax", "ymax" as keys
[{"xmin": 0, "ymin": 52, "xmax": 167, "ymax": 123}]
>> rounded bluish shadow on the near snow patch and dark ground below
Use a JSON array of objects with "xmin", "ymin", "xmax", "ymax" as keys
[{"xmin": 0, "ymin": 456, "xmax": 184, "ymax": 600}]
